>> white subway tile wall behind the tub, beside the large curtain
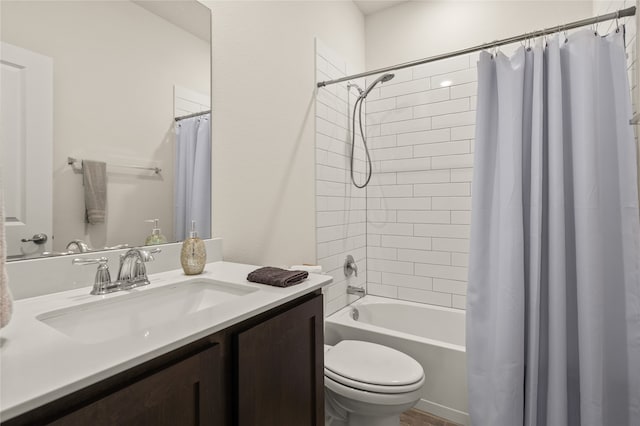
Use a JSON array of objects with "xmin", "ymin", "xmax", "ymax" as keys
[{"xmin": 367, "ymin": 55, "xmax": 477, "ymax": 309}]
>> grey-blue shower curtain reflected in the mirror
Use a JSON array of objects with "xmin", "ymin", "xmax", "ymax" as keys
[{"xmin": 173, "ymin": 114, "xmax": 211, "ymax": 241}]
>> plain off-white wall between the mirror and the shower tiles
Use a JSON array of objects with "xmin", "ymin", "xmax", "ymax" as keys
[{"xmin": 204, "ymin": 1, "xmax": 364, "ymax": 266}]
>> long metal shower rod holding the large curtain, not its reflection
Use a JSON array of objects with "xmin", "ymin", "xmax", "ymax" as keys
[{"xmin": 318, "ymin": 6, "xmax": 636, "ymax": 87}]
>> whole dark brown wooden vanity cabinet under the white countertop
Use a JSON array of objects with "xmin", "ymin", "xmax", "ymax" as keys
[{"xmin": 3, "ymin": 291, "xmax": 324, "ymax": 426}]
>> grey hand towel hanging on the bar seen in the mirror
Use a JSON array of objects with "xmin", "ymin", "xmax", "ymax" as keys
[{"xmin": 82, "ymin": 160, "xmax": 107, "ymax": 225}]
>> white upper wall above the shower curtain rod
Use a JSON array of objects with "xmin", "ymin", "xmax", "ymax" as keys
[{"xmin": 366, "ymin": 0, "xmax": 593, "ymax": 69}]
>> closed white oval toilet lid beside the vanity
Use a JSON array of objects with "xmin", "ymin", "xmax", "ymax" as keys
[{"xmin": 324, "ymin": 340, "xmax": 424, "ymax": 389}]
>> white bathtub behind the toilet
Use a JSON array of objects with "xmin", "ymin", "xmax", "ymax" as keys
[{"xmin": 325, "ymin": 295, "xmax": 470, "ymax": 425}]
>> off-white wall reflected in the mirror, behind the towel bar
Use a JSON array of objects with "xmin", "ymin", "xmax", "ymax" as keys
[{"xmin": 2, "ymin": 1, "xmax": 210, "ymax": 250}]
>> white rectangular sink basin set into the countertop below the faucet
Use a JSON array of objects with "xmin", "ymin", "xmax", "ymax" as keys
[{"xmin": 37, "ymin": 278, "xmax": 258, "ymax": 343}]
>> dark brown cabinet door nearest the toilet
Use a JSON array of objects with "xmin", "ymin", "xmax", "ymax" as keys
[{"xmin": 237, "ymin": 295, "xmax": 324, "ymax": 426}]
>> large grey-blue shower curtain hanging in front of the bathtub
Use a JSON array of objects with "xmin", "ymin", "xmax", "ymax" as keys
[{"xmin": 467, "ymin": 28, "xmax": 640, "ymax": 426}]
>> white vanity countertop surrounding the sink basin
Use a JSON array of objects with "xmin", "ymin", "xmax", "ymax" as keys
[{"xmin": 0, "ymin": 262, "xmax": 331, "ymax": 421}]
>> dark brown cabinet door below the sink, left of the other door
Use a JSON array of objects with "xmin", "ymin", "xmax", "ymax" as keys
[{"xmin": 51, "ymin": 345, "xmax": 224, "ymax": 426}]
